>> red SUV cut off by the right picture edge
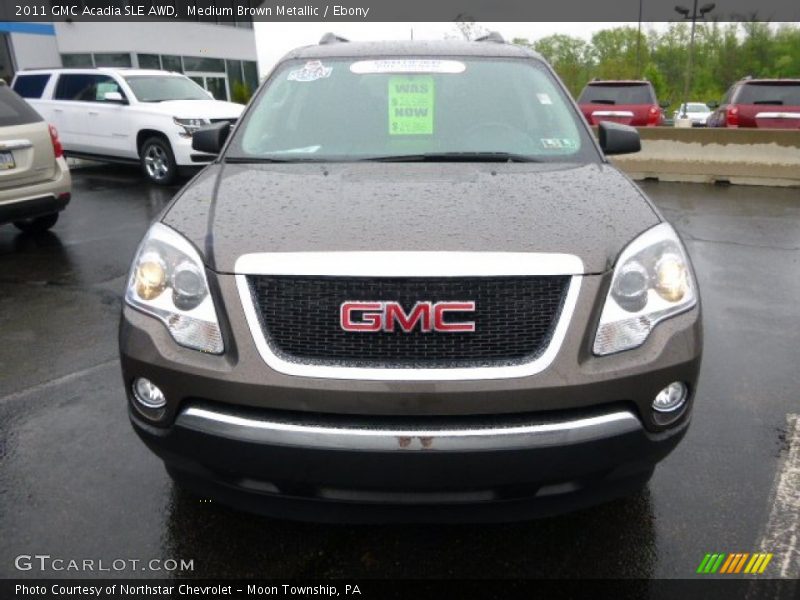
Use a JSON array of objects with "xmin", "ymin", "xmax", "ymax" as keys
[{"xmin": 708, "ymin": 77, "xmax": 800, "ymax": 129}]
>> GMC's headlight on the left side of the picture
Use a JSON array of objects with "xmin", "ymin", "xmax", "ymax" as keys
[{"xmin": 125, "ymin": 223, "xmax": 224, "ymax": 354}]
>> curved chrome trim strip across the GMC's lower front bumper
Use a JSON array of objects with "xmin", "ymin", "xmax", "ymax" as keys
[{"xmin": 175, "ymin": 407, "xmax": 643, "ymax": 452}]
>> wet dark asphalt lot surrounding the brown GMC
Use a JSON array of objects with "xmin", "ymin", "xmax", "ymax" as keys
[{"xmin": 0, "ymin": 166, "xmax": 800, "ymax": 578}]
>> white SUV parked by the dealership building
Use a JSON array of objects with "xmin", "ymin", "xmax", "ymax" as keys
[{"xmin": 13, "ymin": 68, "xmax": 244, "ymax": 184}]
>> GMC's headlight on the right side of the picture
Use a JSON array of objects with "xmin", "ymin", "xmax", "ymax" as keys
[{"xmin": 594, "ymin": 223, "xmax": 697, "ymax": 356}]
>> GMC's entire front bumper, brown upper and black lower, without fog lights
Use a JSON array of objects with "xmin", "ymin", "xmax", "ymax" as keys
[{"xmin": 120, "ymin": 273, "xmax": 702, "ymax": 521}]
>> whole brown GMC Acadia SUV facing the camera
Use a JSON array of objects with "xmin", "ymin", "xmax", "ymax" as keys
[{"xmin": 120, "ymin": 34, "xmax": 702, "ymax": 521}]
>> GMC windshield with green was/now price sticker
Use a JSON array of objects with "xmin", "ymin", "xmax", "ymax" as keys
[{"xmin": 226, "ymin": 58, "xmax": 599, "ymax": 162}]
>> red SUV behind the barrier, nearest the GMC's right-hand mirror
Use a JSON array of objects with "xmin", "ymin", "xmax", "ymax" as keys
[{"xmin": 578, "ymin": 80, "xmax": 669, "ymax": 127}]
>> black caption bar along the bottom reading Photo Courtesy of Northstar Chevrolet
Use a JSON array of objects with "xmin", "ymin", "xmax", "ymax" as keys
[{"xmin": 0, "ymin": 580, "xmax": 798, "ymax": 600}]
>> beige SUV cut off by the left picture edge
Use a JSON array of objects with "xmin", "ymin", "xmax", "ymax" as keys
[{"xmin": 0, "ymin": 80, "xmax": 72, "ymax": 232}]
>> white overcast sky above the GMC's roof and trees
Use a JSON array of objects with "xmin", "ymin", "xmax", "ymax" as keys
[{"xmin": 254, "ymin": 21, "xmax": 666, "ymax": 76}]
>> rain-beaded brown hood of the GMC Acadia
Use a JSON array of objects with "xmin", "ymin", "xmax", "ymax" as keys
[{"xmin": 163, "ymin": 163, "xmax": 660, "ymax": 273}]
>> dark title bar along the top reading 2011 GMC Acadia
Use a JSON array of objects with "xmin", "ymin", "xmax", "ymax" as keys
[{"xmin": 0, "ymin": 0, "xmax": 800, "ymax": 23}]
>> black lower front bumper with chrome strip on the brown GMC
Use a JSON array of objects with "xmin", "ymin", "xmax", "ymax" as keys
[{"xmin": 131, "ymin": 405, "xmax": 688, "ymax": 522}]
